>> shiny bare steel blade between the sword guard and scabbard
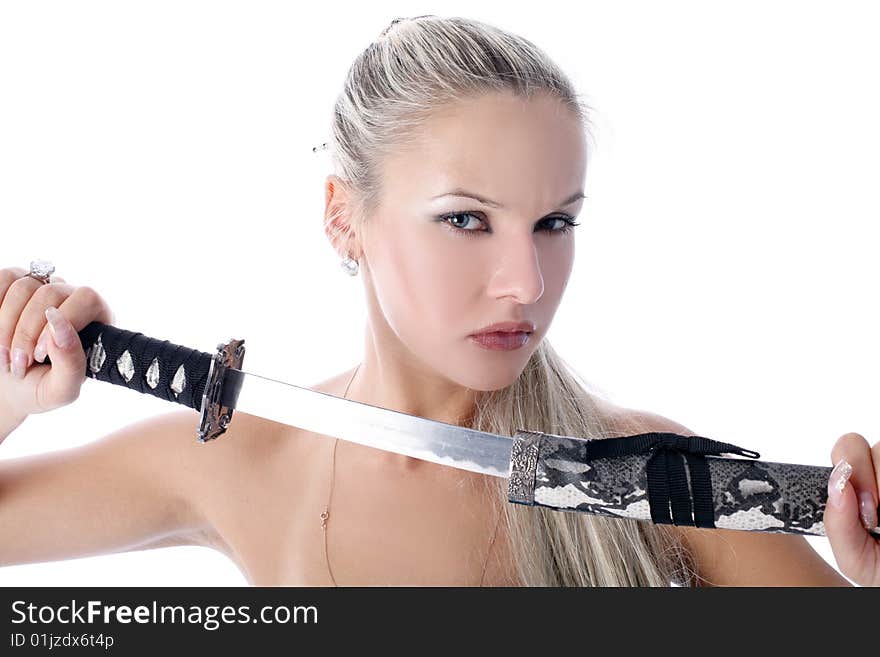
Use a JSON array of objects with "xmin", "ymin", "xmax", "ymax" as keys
[{"xmin": 222, "ymin": 369, "xmax": 513, "ymax": 478}]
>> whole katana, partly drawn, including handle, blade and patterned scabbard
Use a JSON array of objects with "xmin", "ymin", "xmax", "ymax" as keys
[{"xmin": 45, "ymin": 322, "xmax": 880, "ymax": 537}]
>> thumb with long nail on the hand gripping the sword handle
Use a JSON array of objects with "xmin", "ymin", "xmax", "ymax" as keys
[{"xmin": 37, "ymin": 306, "xmax": 86, "ymax": 410}]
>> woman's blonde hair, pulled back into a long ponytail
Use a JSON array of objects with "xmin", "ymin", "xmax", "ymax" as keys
[{"xmin": 328, "ymin": 16, "xmax": 696, "ymax": 586}]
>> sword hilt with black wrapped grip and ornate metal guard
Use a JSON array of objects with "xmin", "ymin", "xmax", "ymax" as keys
[{"xmin": 43, "ymin": 322, "xmax": 245, "ymax": 442}]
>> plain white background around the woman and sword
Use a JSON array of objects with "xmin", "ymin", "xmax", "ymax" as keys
[{"xmin": 0, "ymin": 0, "xmax": 880, "ymax": 586}]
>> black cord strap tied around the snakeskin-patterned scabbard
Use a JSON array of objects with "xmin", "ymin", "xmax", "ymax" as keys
[{"xmin": 586, "ymin": 431, "xmax": 761, "ymax": 527}]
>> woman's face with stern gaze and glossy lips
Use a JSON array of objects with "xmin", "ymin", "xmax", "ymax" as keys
[{"xmin": 360, "ymin": 93, "xmax": 586, "ymax": 390}]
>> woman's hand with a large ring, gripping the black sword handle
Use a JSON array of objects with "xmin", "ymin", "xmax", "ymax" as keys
[{"xmin": 0, "ymin": 267, "xmax": 115, "ymax": 421}]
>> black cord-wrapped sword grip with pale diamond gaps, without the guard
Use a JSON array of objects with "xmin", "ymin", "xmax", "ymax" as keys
[{"xmin": 44, "ymin": 322, "xmax": 214, "ymax": 411}]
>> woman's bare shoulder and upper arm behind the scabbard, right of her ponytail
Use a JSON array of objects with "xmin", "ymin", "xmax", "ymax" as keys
[{"xmin": 611, "ymin": 407, "xmax": 850, "ymax": 586}]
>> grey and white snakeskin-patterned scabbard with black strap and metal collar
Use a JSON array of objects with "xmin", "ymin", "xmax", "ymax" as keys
[{"xmin": 508, "ymin": 431, "xmax": 831, "ymax": 536}]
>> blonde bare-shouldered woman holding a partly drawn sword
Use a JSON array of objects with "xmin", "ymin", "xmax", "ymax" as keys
[{"xmin": 0, "ymin": 16, "xmax": 880, "ymax": 586}]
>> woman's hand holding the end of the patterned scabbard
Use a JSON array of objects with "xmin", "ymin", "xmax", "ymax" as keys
[{"xmin": 823, "ymin": 433, "xmax": 880, "ymax": 586}]
